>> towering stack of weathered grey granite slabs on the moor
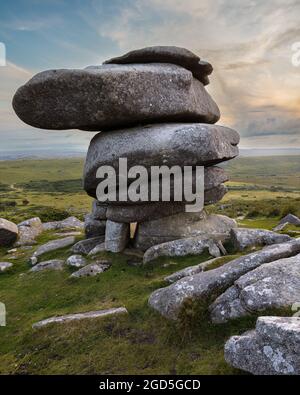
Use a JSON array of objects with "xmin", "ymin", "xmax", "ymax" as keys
[{"xmin": 13, "ymin": 47, "xmax": 239, "ymax": 252}]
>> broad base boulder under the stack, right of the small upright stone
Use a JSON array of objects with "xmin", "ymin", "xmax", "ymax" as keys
[{"xmin": 134, "ymin": 211, "xmax": 237, "ymax": 251}]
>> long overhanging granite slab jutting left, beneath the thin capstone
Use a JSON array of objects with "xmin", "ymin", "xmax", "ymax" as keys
[{"xmin": 13, "ymin": 63, "xmax": 220, "ymax": 131}]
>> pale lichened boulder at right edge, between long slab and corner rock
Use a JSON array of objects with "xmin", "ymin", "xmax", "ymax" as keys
[{"xmin": 210, "ymin": 254, "xmax": 300, "ymax": 323}]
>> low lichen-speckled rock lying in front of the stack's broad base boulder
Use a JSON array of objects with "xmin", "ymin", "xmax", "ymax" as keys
[{"xmin": 143, "ymin": 236, "xmax": 221, "ymax": 264}]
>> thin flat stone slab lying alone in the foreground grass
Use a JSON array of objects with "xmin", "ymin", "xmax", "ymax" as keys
[{"xmin": 32, "ymin": 307, "xmax": 128, "ymax": 329}]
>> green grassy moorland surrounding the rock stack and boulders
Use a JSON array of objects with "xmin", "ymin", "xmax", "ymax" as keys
[{"xmin": 0, "ymin": 157, "xmax": 300, "ymax": 374}]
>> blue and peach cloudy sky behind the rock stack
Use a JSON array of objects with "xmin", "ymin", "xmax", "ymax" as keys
[{"xmin": 0, "ymin": 0, "xmax": 300, "ymax": 155}]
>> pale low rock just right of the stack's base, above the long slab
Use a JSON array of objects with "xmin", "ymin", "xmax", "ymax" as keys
[{"xmin": 230, "ymin": 228, "xmax": 291, "ymax": 251}]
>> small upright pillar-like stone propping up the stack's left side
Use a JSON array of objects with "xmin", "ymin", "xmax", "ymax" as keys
[{"xmin": 105, "ymin": 220, "xmax": 130, "ymax": 252}]
